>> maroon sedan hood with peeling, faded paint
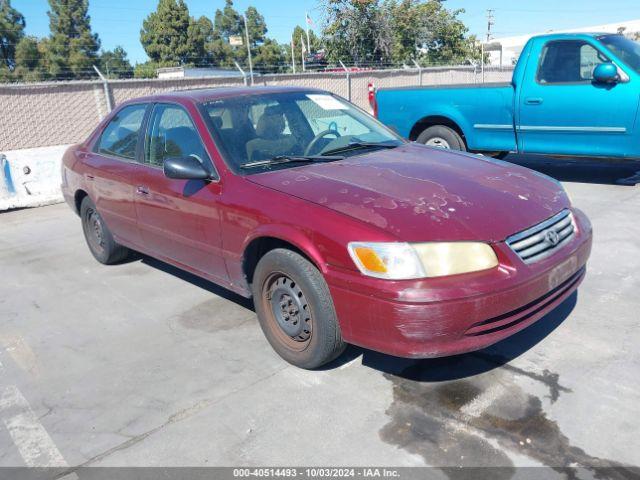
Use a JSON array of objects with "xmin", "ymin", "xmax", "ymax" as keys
[{"xmin": 247, "ymin": 144, "xmax": 569, "ymax": 242}]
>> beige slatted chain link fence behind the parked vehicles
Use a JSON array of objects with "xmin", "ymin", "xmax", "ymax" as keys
[{"xmin": 0, "ymin": 66, "xmax": 513, "ymax": 152}]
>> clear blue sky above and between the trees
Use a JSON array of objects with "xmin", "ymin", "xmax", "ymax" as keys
[{"xmin": 11, "ymin": 0, "xmax": 640, "ymax": 64}]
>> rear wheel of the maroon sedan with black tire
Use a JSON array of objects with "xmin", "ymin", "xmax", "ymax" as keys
[{"xmin": 80, "ymin": 197, "xmax": 130, "ymax": 265}]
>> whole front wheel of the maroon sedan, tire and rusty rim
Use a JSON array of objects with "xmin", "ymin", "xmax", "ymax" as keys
[{"xmin": 252, "ymin": 248, "xmax": 346, "ymax": 369}]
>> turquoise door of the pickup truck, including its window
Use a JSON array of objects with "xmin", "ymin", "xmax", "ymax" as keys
[{"xmin": 516, "ymin": 39, "xmax": 639, "ymax": 157}]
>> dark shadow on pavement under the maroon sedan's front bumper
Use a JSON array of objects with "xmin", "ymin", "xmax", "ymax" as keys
[{"xmin": 323, "ymin": 292, "xmax": 578, "ymax": 382}]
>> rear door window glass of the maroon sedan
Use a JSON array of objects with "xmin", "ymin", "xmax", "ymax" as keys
[{"xmin": 97, "ymin": 105, "xmax": 147, "ymax": 160}]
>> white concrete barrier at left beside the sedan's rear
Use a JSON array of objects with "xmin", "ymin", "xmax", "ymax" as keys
[{"xmin": 0, "ymin": 145, "xmax": 68, "ymax": 211}]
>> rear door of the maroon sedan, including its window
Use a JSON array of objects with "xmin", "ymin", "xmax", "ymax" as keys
[{"xmin": 83, "ymin": 103, "xmax": 148, "ymax": 247}]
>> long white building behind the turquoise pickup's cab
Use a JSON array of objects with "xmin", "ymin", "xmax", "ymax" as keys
[{"xmin": 485, "ymin": 19, "xmax": 640, "ymax": 66}]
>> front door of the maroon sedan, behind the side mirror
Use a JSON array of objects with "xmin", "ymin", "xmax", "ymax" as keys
[{"xmin": 135, "ymin": 103, "xmax": 228, "ymax": 281}]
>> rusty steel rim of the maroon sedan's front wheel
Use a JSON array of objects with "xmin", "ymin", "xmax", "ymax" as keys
[{"xmin": 262, "ymin": 272, "xmax": 313, "ymax": 351}]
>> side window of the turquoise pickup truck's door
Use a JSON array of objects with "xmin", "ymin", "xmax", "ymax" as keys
[{"xmin": 537, "ymin": 40, "xmax": 609, "ymax": 84}]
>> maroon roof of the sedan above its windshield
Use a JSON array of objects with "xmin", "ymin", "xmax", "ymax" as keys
[{"xmin": 127, "ymin": 86, "xmax": 327, "ymax": 103}]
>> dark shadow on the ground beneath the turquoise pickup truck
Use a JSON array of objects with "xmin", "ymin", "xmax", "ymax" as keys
[{"xmin": 504, "ymin": 154, "xmax": 640, "ymax": 186}]
